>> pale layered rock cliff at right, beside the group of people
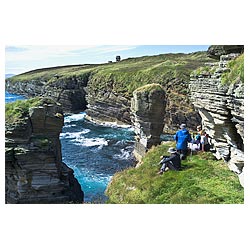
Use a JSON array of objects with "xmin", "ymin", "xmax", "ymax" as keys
[{"xmin": 189, "ymin": 54, "xmax": 244, "ymax": 186}]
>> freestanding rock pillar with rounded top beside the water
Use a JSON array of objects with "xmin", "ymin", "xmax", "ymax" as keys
[{"xmin": 131, "ymin": 84, "xmax": 166, "ymax": 160}]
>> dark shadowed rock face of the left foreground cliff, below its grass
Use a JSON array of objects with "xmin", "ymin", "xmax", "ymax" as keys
[{"xmin": 5, "ymin": 97, "xmax": 83, "ymax": 204}]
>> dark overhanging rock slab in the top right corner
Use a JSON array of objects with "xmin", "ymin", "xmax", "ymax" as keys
[{"xmin": 207, "ymin": 45, "xmax": 244, "ymax": 60}]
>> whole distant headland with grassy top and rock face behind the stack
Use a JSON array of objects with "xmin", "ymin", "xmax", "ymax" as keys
[{"xmin": 6, "ymin": 52, "xmax": 215, "ymax": 132}]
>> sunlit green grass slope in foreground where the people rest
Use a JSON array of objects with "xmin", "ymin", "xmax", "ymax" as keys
[{"xmin": 106, "ymin": 144, "xmax": 244, "ymax": 204}]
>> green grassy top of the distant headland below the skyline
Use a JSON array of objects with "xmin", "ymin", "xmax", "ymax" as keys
[{"xmin": 8, "ymin": 52, "xmax": 214, "ymax": 95}]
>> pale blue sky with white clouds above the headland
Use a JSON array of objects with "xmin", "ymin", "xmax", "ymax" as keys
[{"xmin": 5, "ymin": 45, "xmax": 208, "ymax": 74}]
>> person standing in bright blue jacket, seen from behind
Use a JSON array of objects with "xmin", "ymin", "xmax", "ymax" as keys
[{"xmin": 174, "ymin": 124, "xmax": 192, "ymax": 160}]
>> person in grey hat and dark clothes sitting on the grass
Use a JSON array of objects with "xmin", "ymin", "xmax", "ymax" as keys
[{"xmin": 158, "ymin": 148, "xmax": 181, "ymax": 174}]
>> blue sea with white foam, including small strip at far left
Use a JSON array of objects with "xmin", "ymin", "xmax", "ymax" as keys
[{"xmin": 5, "ymin": 92, "xmax": 135, "ymax": 204}]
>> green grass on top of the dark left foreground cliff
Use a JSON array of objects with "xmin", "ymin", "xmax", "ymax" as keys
[{"xmin": 5, "ymin": 97, "xmax": 54, "ymax": 124}]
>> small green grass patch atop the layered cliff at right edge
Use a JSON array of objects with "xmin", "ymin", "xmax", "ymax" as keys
[{"xmin": 221, "ymin": 54, "xmax": 244, "ymax": 84}]
